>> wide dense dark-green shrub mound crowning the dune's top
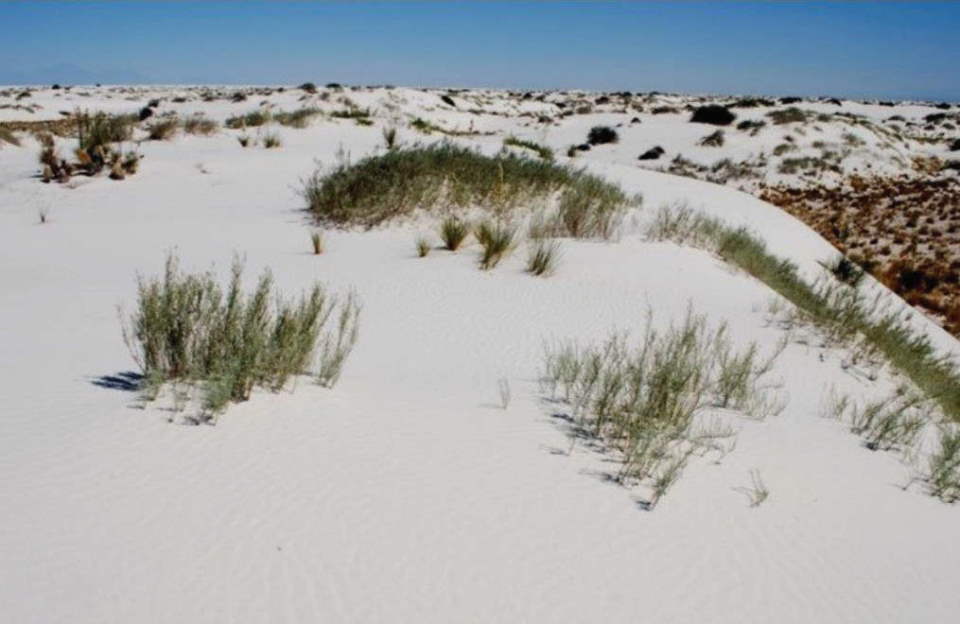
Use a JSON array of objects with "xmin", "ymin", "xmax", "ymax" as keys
[{"xmin": 302, "ymin": 142, "xmax": 639, "ymax": 236}]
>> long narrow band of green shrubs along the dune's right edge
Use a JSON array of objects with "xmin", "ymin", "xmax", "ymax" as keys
[{"xmin": 647, "ymin": 208, "xmax": 960, "ymax": 423}]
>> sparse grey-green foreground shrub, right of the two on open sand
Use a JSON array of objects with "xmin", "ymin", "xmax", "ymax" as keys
[{"xmin": 541, "ymin": 310, "xmax": 776, "ymax": 508}]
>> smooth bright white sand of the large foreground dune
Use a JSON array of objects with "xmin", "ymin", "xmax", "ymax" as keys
[{"xmin": 0, "ymin": 86, "xmax": 960, "ymax": 624}]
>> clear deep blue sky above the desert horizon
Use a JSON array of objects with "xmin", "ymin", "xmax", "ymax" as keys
[{"xmin": 0, "ymin": 0, "xmax": 960, "ymax": 100}]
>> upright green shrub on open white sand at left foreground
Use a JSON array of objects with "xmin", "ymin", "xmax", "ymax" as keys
[{"xmin": 123, "ymin": 255, "xmax": 358, "ymax": 419}]
